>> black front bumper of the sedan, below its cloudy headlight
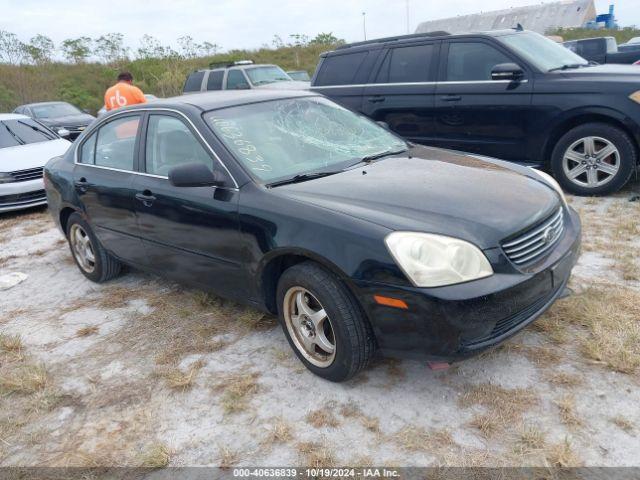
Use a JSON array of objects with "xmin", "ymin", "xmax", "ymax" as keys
[{"xmin": 356, "ymin": 209, "xmax": 581, "ymax": 362}]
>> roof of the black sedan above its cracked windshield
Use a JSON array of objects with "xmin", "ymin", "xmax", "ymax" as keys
[{"xmin": 117, "ymin": 89, "xmax": 321, "ymax": 111}]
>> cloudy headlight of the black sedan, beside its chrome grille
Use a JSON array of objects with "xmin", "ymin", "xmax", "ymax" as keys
[{"xmin": 385, "ymin": 232, "xmax": 493, "ymax": 287}]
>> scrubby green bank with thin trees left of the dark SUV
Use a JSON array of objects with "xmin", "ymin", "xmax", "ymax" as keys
[{"xmin": 0, "ymin": 32, "xmax": 344, "ymax": 112}]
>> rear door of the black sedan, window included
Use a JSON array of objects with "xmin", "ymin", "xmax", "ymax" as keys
[{"xmin": 73, "ymin": 114, "xmax": 144, "ymax": 264}]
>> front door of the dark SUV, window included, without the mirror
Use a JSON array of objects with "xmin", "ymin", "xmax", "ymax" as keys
[{"xmin": 435, "ymin": 39, "xmax": 534, "ymax": 161}]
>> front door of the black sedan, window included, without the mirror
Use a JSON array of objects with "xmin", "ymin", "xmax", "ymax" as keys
[{"xmin": 133, "ymin": 113, "xmax": 248, "ymax": 297}]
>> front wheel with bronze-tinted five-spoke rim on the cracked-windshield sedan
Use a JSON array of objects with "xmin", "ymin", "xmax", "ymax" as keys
[{"xmin": 277, "ymin": 262, "xmax": 375, "ymax": 382}]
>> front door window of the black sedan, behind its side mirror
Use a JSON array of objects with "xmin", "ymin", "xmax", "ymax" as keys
[{"xmin": 145, "ymin": 115, "xmax": 213, "ymax": 177}]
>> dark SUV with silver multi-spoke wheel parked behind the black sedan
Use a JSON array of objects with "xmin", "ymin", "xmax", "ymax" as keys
[{"xmin": 311, "ymin": 29, "xmax": 640, "ymax": 195}]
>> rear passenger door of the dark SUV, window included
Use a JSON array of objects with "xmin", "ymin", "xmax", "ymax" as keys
[{"xmin": 361, "ymin": 41, "xmax": 440, "ymax": 144}]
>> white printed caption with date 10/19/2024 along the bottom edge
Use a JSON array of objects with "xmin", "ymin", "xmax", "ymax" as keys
[{"xmin": 233, "ymin": 468, "xmax": 400, "ymax": 479}]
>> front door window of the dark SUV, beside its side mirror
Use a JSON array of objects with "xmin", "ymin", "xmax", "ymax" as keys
[{"xmin": 446, "ymin": 42, "xmax": 511, "ymax": 82}]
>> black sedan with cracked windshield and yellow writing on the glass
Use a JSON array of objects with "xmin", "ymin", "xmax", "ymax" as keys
[{"xmin": 45, "ymin": 91, "xmax": 580, "ymax": 381}]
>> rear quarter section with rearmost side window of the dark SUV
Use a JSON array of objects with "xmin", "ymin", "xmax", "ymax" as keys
[{"xmin": 311, "ymin": 49, "xmax": 380, "ymax": 111}]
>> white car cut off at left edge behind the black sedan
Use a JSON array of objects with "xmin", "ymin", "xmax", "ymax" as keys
[{"xmin": 0, "ymin": 113, "xmax": 71, "ymax": 212}]
